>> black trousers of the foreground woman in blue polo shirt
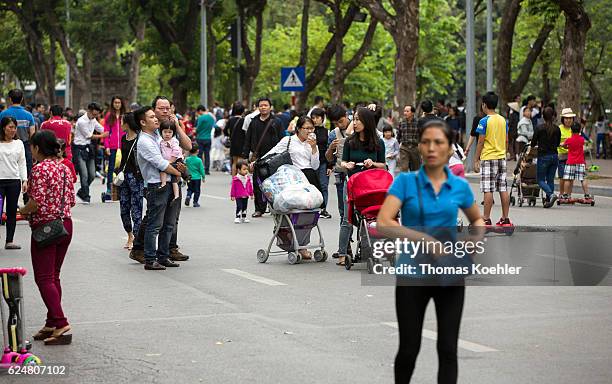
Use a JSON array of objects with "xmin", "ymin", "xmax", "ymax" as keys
[{"xmin": 394, "ymin": 286, "xmax": 465, "ymax": 384}]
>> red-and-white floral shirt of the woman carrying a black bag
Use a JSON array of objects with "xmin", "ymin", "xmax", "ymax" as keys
[{"xmin": 28, "ymin": 159, "xmax": 75, "ymax": 226}]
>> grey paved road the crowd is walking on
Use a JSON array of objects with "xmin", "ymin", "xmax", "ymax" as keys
[{"xmin": 0, "ymin": 174, "xmax": 612, "ymax": 384}]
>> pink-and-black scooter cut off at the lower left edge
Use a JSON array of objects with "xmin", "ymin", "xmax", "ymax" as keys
[{"xmin": 0, "ymin": 268, "xmax": 41, "ymax": 369}]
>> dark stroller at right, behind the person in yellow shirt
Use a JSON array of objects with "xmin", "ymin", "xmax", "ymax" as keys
[{"xmin": 510, "ymin": 145, "xmax": 540, "ymax": 207}]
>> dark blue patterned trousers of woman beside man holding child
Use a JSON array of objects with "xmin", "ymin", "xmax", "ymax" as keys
[{"xmin": 119, "ymin": 172, "xmax": 144, "ymax": 233}]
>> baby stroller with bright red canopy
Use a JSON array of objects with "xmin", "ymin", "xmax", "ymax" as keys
[{"xmin": 344, "ymin": 169, "xmax": 395, "ymax": 274}]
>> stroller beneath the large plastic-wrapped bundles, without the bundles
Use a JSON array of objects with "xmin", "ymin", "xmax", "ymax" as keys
[{"xmin": 256, "ymin": 164, "xmax": 327, "ymax": 264}]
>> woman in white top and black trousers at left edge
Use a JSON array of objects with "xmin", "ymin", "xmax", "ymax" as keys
[{"xmin": 0, "ymin": 116, "xmax": 28, "ymax": 249}]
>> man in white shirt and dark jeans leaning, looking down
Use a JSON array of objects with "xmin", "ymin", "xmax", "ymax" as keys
[{"xmin": 72, "ymin": 103, "xmax": 108, "ymax": 203}]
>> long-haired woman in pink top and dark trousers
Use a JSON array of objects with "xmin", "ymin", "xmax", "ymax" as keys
[{"xmin": 104, "ymin": 96, "xmax": 125, "ymax": 200}]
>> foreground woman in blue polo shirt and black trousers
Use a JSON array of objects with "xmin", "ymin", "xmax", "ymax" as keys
[{"xmin": 377, "ymin": 120, "xmax": 484, "ymax": 383}]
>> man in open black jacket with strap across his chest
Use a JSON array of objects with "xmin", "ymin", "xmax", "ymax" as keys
[{"xmin": 242, "ymin": 97, "xmax": 285, "ymax": 217}]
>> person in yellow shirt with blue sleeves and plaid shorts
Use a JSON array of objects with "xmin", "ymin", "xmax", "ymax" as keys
[{"xmin": 474, "ymin": 92, "xmax": 512, "ymax": 227}]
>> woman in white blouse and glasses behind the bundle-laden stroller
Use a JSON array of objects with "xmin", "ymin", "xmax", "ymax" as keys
[{"xmin": 266, "ymin": 116, "xmax": 321, "ymax": 191}]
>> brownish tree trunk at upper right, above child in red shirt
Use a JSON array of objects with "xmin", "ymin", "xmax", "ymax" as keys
[{"xmin": 558, "ymin": 0, "xmax": 591, "ymax": 115}]
